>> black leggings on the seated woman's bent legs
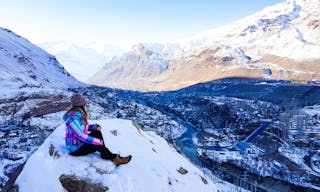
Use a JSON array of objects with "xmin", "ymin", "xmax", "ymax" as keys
[{"xmin": 70, "ymin": 130, "xmax": 117, "ymax": 160}]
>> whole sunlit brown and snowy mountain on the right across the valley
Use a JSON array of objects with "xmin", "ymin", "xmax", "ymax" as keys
[{"xmin": 90, "ymin": 0, "xmax": 320, "ymax": 90}]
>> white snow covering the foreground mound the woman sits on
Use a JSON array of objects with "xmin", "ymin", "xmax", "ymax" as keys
[{"xmin": 16, "ymin": 119, "xmax": 228, "ymax": 192}]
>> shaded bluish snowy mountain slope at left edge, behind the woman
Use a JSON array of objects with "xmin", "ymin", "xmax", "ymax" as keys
[{"xmin": 0, "ymin": 28, "xmax": 85, "ymax": 122}]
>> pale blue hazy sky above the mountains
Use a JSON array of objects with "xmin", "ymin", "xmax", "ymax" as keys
[{"xmin": 0, "ymin": 0, "xmax": 282, "ymax": 48}]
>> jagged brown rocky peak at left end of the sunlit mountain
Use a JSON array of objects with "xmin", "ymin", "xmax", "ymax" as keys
[{"xmin": 89, "ymin": 44, "xmax": 168, "ymax": 89}]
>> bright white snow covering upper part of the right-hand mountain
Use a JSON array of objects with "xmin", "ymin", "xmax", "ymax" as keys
[{"xmin": 177, "ymin": 0, "xmax": 320, "ymax": 59}]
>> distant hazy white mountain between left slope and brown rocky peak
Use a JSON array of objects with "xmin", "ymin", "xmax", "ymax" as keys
[{"xmin": 39, "ymin": 41, "xmax": 124, "ymax": 82}]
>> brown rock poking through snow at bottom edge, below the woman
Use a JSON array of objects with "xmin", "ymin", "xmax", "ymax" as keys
[{"xmin": 59, "ymin": 174, "xmax": 108, "ymax": 192}]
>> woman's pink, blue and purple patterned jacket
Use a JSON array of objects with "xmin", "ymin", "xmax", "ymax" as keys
[{"xmin": 63, "ymin": 110, "xmax": 103, "ymax": 153}]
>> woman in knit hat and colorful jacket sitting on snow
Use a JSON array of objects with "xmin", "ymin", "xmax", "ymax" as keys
[{"xmin": 63, "ymin": 93, "xmax": 131, "ymax": 166}]
